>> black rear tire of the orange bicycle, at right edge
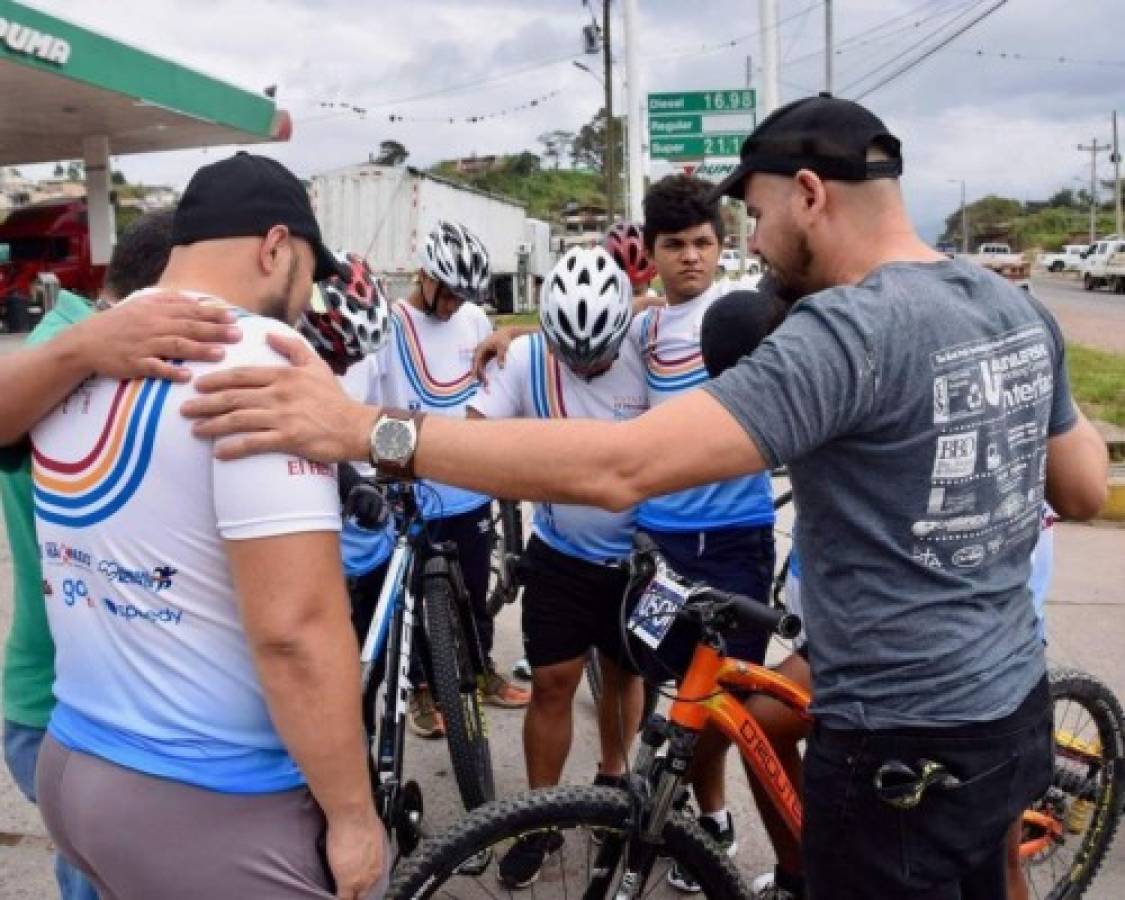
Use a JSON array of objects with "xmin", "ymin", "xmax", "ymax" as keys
[{"xmin": 1024, "ymin": 668, "xmax": 1125, "ymax": 900}]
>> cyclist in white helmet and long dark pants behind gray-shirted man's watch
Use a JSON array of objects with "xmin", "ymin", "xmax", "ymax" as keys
[{"xmin": 348, "ymin": 222, "xmax": 529, "ymax": 738}]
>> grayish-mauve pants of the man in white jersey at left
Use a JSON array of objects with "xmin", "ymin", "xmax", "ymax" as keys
[{"xmin": 36, "ymin": 735, "xmax": 389, "ymax": 900}]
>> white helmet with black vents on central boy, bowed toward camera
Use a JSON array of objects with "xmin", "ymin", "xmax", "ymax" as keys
[{"xmin": 539, "ymin": 246, "xmax": 632, "ymax": 374}]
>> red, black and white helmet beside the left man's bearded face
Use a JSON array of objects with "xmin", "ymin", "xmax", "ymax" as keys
[{"xmin": 297, "ymin": 253, "xmax": 390, "ymax": 375}]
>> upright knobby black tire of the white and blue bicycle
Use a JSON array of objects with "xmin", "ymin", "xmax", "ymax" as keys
[{"xmin": 422, "ymin": 577, "xmax": 496, "ymax": 809}]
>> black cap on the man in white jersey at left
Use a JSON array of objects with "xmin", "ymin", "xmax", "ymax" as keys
[{"xmin": 172, "ymin": 151, "xmax": 347, "ymax": 281}]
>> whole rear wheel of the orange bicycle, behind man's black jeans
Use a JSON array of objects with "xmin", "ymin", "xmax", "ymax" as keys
[{"xmin": 1020, "ymin": 669, "xmax": 1125, "ymax": 900}]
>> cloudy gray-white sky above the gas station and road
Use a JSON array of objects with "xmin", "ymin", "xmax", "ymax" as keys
[{"xmin": 17, "ymin": 0, "xmax": 1125, "ymax": 239}]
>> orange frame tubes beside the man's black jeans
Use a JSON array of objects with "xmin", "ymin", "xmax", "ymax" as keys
[{"xmin": 669, "ymin": 644, "xmax": 811, "ymax": 838}]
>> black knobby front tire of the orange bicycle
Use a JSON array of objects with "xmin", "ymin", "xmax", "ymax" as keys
[{"xmin": 387, "ymin": 785, "xmax": 753, "ymax": 900}]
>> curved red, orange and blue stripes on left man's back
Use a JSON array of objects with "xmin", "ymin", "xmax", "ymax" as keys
[{"xmin": 32, "ymin": 378, "xmax": 172, "ymax": 528}]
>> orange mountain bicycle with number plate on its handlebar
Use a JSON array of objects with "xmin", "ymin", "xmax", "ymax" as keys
[{"xmin": 387, "ymin": 541, "xmax": 1122, "ymax": 900}]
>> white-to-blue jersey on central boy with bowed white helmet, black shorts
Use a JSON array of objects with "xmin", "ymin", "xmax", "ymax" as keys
[{"xmin": 469, "ymin": 334, "xmax": 648, "ymax": 563}]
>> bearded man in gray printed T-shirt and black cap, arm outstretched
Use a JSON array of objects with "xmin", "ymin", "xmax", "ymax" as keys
[{"xmin": 186, "ymin": 97, "xmax": 1108, "ymax": 900}]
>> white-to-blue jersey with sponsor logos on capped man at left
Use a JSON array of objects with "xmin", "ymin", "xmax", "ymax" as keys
[{"xmin": 32, "ymin": 299, "xmax": 340, "ymax": 793}]
